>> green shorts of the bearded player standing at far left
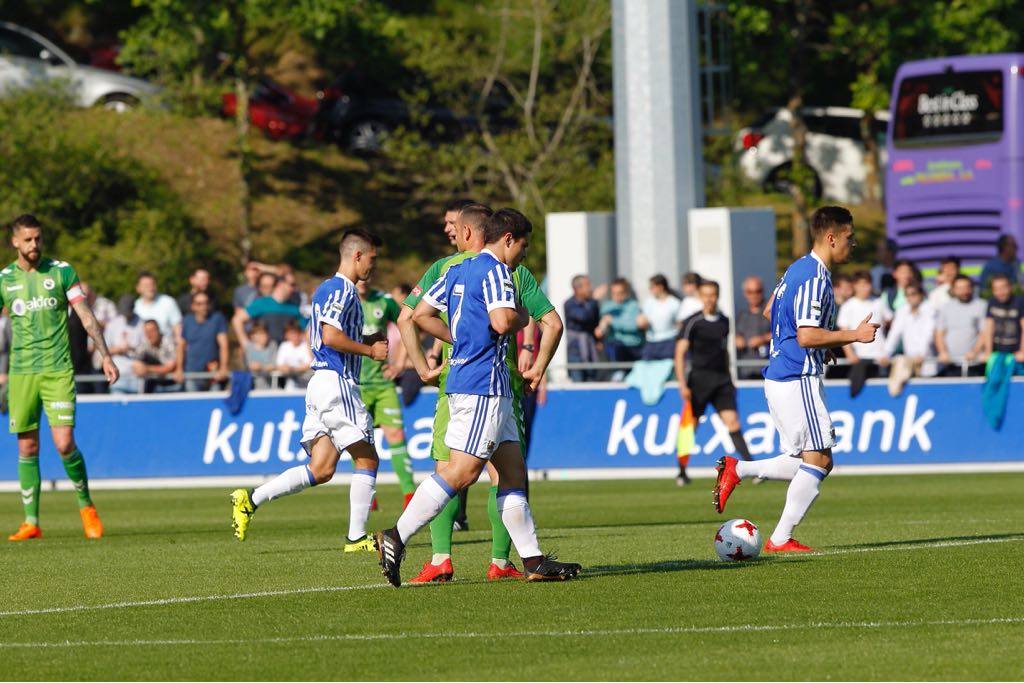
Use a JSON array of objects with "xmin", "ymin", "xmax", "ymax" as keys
[{"xmin": 7, "ymin": 370, "xmax": 75, "ymax": 434}]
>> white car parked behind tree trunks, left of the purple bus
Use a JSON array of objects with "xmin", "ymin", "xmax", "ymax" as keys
[{"xmin": 735, "ymin": 106, "xmax": 889, "ymax": 204}]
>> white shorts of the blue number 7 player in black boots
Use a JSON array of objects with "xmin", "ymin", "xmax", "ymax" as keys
[{"xmin": 444, "ymin": 393, "xmax": 519, "ymax": 460}]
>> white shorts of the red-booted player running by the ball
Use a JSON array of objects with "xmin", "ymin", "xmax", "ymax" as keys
[{"xmin": 765, "ymin": 377, "xmax": 836, "ymax": 456}]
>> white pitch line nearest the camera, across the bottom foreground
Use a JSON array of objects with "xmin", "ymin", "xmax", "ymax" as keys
[{"xmin": 0, "ymin": 616, "xmax": 1024, "ymax": 649}]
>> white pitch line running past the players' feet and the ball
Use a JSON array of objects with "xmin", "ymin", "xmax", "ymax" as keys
[{"xmin": 0, "ymin": 535, "xmax": 1024, "ymax": 622}]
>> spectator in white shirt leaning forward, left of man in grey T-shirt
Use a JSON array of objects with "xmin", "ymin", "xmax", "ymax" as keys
[{"xmin": 882, "ymin": 283, "xmax": 935, "ymax": 396}]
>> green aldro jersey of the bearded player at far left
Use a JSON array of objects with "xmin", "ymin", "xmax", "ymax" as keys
[{"xmin": 0, "ymin": 258, "xmax": 85, "ymax": 375}]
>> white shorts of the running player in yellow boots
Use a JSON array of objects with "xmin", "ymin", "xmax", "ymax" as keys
[{"xmin": 302, "ymin": 370, "xmax": 374, "ymax": 453}]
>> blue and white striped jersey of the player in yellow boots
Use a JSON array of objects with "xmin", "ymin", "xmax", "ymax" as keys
[{"xmin": 309, "ymin": 272, "xmax": 362, "ymax": 384}]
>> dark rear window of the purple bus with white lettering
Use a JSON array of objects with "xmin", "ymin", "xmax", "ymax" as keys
[{"xmin": 893, "ymin": 71, "xmax": 1002, "ymax": 147}]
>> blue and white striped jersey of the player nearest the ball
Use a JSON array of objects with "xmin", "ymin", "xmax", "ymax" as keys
[{"xmin": 764, "ymin": 252, "xmax": 836, "ymax": 382}]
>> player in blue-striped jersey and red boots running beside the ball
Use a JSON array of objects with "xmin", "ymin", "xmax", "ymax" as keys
[{"xmin": 714, "ymin": 206, "xmax": 879, "ymax": 553}]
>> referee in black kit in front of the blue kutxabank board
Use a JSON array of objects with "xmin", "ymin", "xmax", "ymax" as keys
[{"xmin": 676, "ymin": 280, "xmax": 751, "ymax": 471}]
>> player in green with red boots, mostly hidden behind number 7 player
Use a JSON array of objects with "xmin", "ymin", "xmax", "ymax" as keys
[{"xmin": 398, "ymin": 204, "xmax": 562, "ymax": 584}]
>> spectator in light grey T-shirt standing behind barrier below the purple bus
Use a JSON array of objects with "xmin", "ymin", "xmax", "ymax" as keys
[{"xmin": 928, "ymin": 274, "xmax": 987, "ymax": 377}]
